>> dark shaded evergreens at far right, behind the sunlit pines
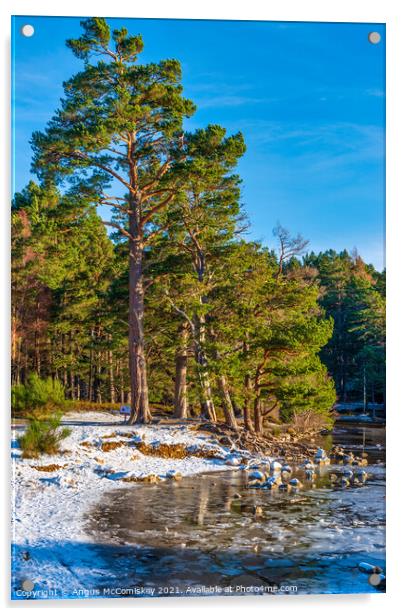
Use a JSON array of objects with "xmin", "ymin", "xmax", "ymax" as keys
[{"xmin": 304, "ymin": 250, "xmax": 385, "ymax": 402}]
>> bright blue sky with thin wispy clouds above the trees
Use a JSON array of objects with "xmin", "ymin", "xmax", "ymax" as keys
[{"xmin": 13, "ymin": 17, "xmax": 385, "ymax": 269}]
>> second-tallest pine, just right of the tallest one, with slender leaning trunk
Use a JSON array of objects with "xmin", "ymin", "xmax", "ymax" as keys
[{"xmin": 155, "ymin": 125, "xmax": 245, "ymax": 429}]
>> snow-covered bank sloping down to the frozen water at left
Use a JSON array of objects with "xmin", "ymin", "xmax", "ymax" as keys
[{"xmin": 12, "ymin": 412, "xmax": 268, "ymax": 598}]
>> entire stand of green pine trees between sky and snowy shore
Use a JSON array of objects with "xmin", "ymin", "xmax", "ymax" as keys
[{"xmin": 12, "ymin": 18, "xmax": 385, "ymax": 433}]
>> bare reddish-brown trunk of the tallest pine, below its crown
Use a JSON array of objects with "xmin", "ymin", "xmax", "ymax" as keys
[{"xmin": 128, "ymin": 225, "xmax": 152, "ymax": 424}]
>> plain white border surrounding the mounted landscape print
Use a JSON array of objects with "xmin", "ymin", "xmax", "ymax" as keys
[{"xmin": 0, "ymin": 0, "xmax": 402, "ymax": 616}]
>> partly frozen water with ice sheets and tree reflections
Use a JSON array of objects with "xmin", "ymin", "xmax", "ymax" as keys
[{"xmin": 86, "ymin": 426, "xmax": 385, "ymax": 594}]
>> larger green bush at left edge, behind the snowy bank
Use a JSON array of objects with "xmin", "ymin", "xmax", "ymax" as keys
[{"xmin": 11, "ymin": 373, "xmax": 65, "ymax": 412}]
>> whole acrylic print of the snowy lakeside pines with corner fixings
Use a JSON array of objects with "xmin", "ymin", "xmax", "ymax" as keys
[{"xmin": 11, "ymin": 16, "xmax": 386, "ymax": 600}]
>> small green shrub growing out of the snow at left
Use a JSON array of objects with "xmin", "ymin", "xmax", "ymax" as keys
[{"xmin": 19, "ymin": 413, "xmax": 71, "ymax": 458}]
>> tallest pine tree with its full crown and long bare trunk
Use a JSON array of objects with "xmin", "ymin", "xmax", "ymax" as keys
[{"xmin": 32, "ymin": 18, "xmax": 194, "ymax": 422}]
